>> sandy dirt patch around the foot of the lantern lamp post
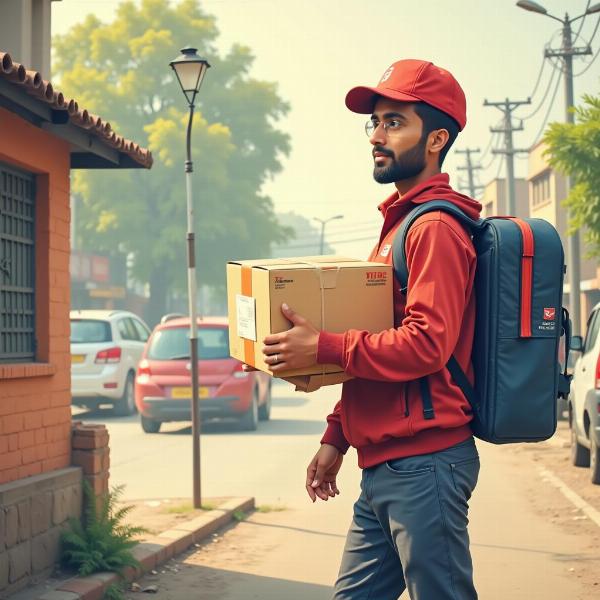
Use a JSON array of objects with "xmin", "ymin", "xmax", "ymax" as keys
[{"xmin": 118, "ymin": 498, "xmax": 227, "ymax": 541}]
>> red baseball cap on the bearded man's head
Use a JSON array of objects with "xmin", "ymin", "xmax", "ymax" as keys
[{"xmin": 346, "ymin": 59, "xmax": 467, "ymax": 130}]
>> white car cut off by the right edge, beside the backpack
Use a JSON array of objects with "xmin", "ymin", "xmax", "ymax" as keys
[{"xmin": 569, "ymin": 304, "xmax": 600, "ymax": 484}]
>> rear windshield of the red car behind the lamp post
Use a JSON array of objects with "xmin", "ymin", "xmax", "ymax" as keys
[{"xmin": 148, "ymin": 327, "xmax": 229, "ymax": 360}]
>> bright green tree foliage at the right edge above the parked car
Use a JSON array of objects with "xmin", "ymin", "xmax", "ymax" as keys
[{"xmin": 544, "ymin": 95, "xmax": 600, "ymax": 256}]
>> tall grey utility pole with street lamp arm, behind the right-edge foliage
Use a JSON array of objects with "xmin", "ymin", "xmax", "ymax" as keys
[{"xmin": 517, "ymin": 0, "xmax": 600, "ymax": 335}]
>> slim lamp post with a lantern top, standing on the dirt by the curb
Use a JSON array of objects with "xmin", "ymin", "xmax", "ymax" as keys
[{"xmin": 169, "ymin": 47, "xmax": 210, "ymax": 508}]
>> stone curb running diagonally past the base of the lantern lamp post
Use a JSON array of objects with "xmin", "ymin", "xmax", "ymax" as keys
[{"xmin": 31, "ymin": 497, "xmax": 255, "ymax": 600}]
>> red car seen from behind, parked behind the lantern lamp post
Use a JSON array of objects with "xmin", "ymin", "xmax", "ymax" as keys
[{"xmin": 135, "ymin": 317, "xmax": 271, "ymax": 433}]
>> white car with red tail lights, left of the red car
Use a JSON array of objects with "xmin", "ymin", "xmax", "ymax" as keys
[{"xmin": 70, "ymin": 310, "xmax": 150, "ymax": 415}]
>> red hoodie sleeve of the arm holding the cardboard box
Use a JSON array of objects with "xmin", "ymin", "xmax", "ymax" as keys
[{"xmin": 317, "ymin": 213, "xmax": 476, "ymax": 381}]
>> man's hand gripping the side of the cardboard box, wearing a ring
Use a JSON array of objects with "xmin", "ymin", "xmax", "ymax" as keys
[{"xmin": 262, "ymin": 304, "xmax": 319, "ymax": 374}]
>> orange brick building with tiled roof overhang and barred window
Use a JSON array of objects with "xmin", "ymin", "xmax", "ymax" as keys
[{"xmin": 0, "ymin": 52, "xmax": 152, "ymax": 597}]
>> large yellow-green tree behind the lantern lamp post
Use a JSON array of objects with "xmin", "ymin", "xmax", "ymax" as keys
[{"xmin": 53, "ymin": 0, "xmax": 289, "ymax": 322}]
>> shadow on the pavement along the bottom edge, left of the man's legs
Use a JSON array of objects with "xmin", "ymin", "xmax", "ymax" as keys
[{"xmin": 140, "ymin": 558, "xmax": 331, "ymax": 600}]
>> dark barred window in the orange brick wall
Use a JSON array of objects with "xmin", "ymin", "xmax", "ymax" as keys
[{"xmin": 0, "ymin": 163, "xmax": 35, "ymax": 363}]
